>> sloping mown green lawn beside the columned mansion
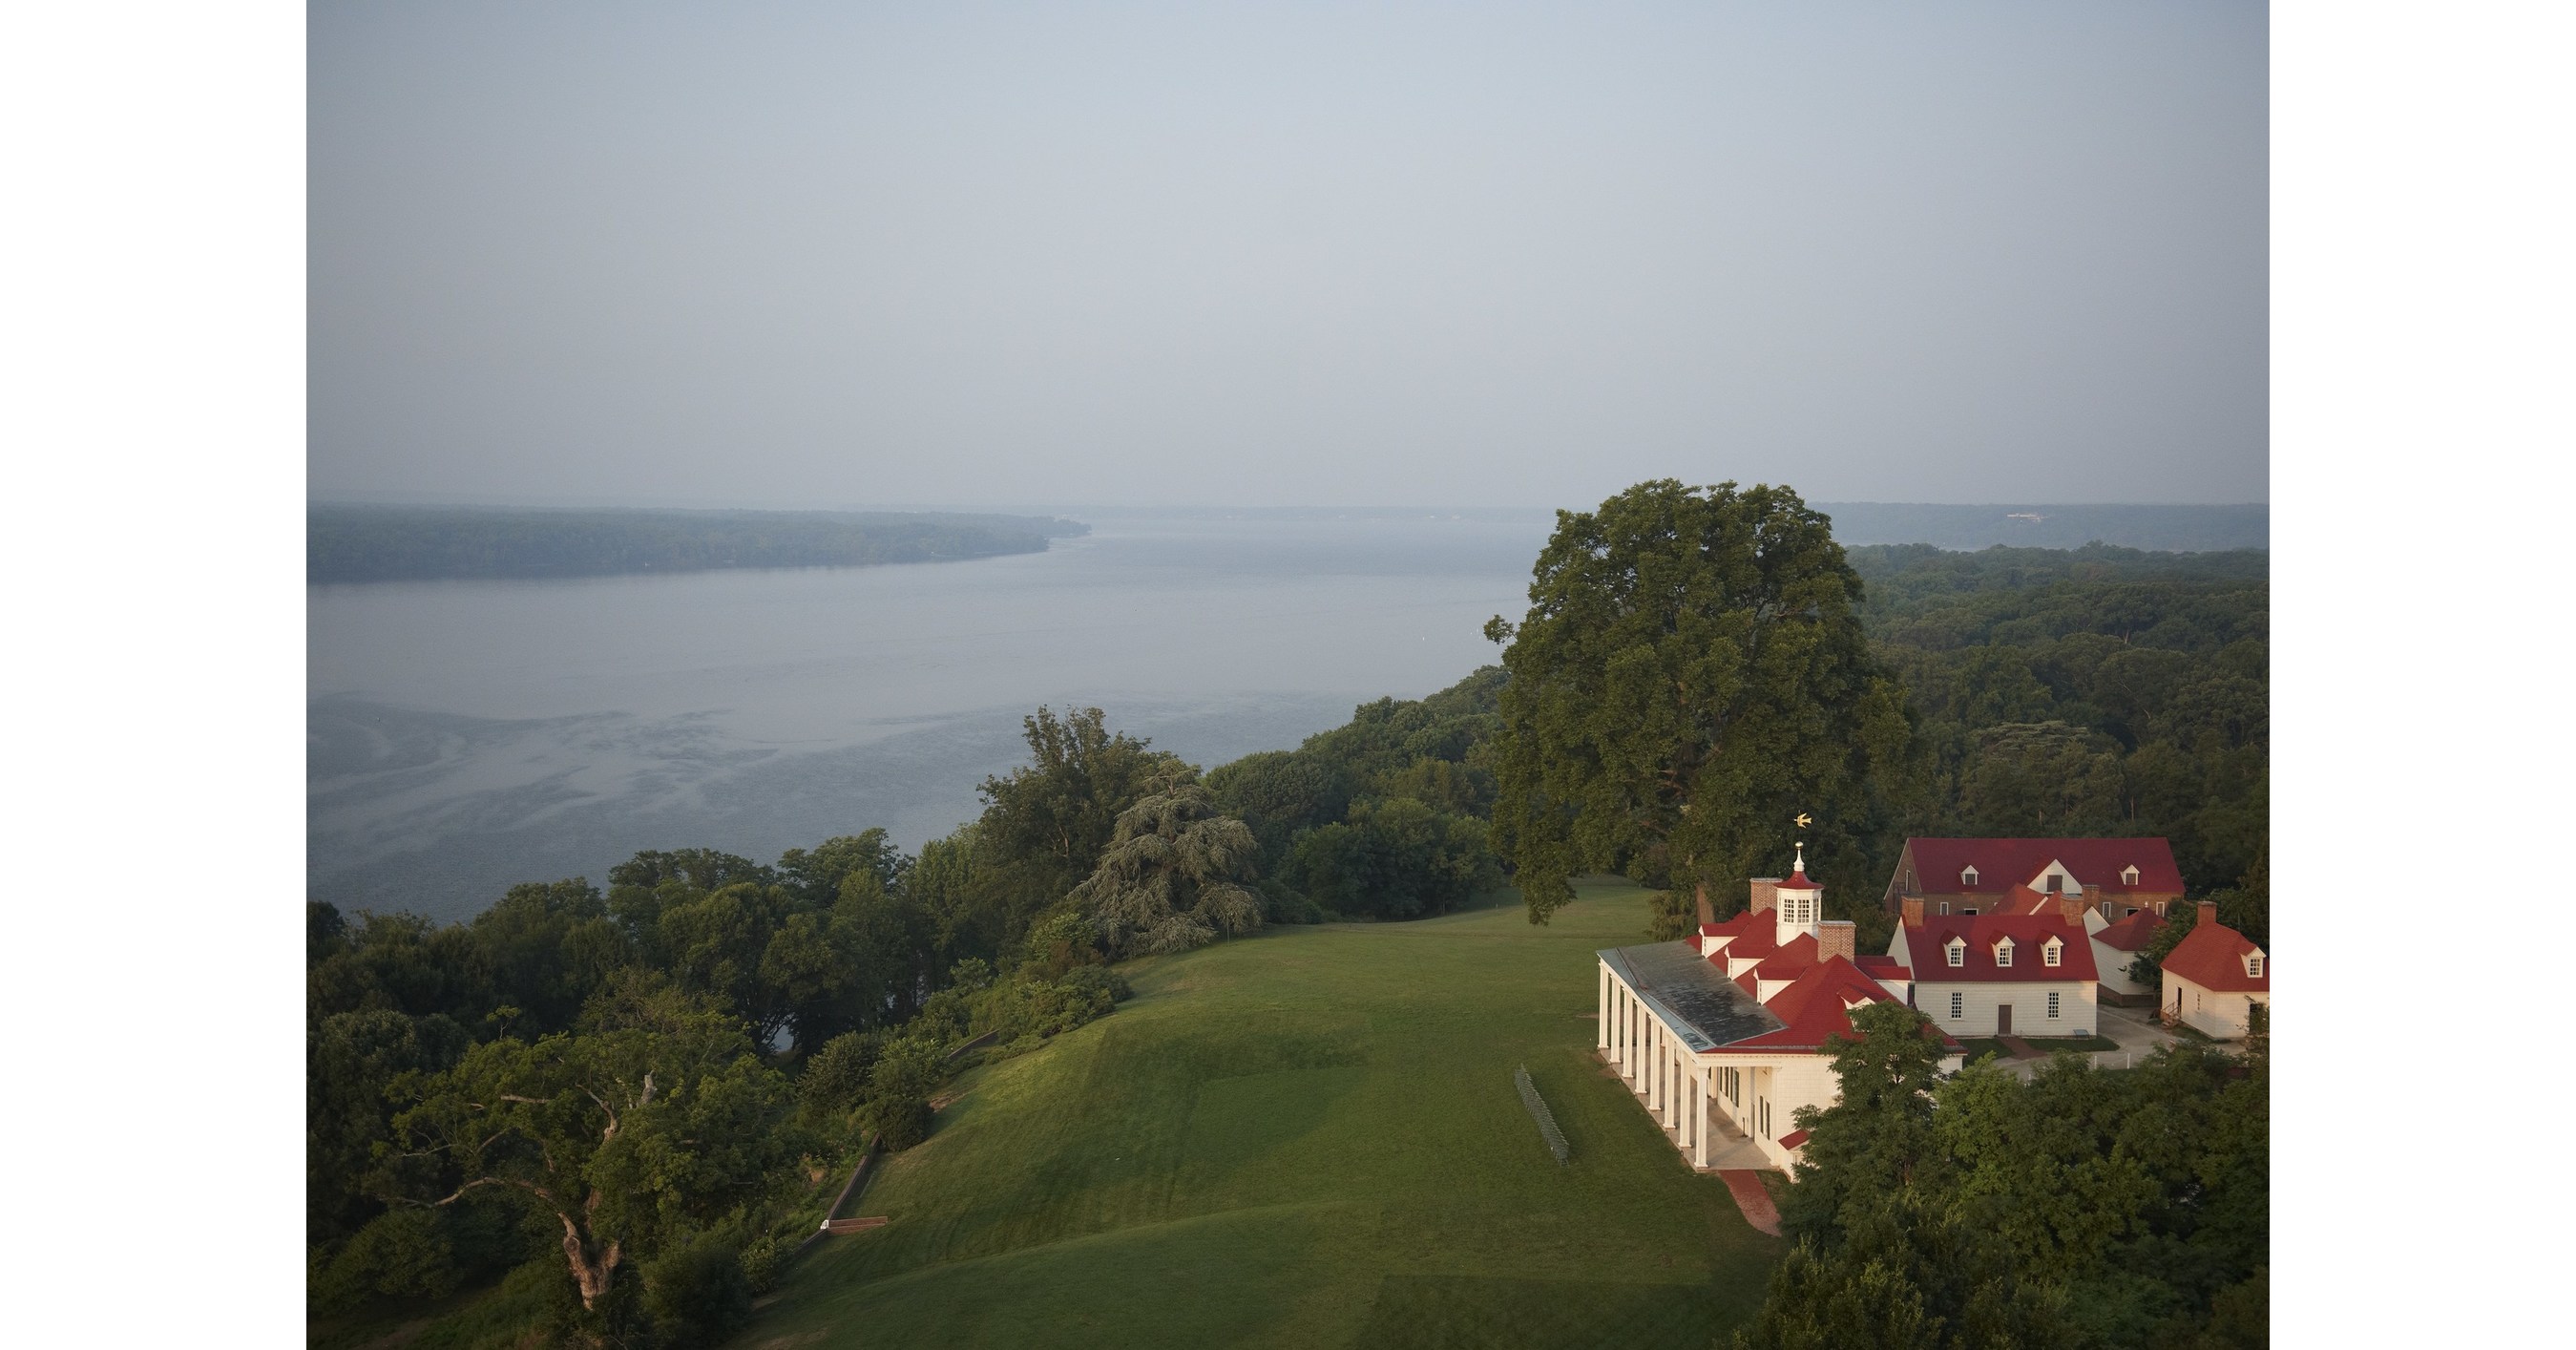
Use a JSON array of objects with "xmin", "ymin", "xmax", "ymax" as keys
[{"xmin": 737, "ymin": 886, "xmax": 1780, "ymax": 1350}]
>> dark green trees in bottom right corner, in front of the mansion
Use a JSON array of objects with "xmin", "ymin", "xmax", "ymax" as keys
[{"xmin": 1736, "ymin": 1002, "xmax": 2272, "ymax": 1350}]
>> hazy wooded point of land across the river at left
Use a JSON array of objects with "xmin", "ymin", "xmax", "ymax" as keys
[{"xmin": 304, "ymin": 505, "xmax": 1090, "ymax": 585}]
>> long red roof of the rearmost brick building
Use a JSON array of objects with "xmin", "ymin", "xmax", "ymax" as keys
[{"xmin": 1886, "ymin": 837, "xmax": 2182, "ymax": 919}]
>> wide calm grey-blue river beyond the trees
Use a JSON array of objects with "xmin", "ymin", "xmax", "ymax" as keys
[{"xmin": 306, "ymin": 513, "xmax": 1551, "ymax": 918}]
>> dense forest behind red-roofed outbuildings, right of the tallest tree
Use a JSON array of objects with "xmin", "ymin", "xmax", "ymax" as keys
[{"xmin": 1853, "ymin": 543, "xmax": 2272, "ymax": 892}]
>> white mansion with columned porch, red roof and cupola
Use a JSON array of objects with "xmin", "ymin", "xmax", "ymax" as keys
[{"xmin": 1595, "ymin": 848, "xmax": 1958, "ymax": 1170}]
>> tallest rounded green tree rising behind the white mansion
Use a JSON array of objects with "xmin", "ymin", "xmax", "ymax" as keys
[{"xmin": 1486, "ymin": 479, "xmax": 1909, "ymax": 922}]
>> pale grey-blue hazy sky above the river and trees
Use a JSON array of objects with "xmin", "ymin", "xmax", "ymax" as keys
[{"xmin": 312, "ymin": 0, "xmax": 2270, "ymax": 508}]
